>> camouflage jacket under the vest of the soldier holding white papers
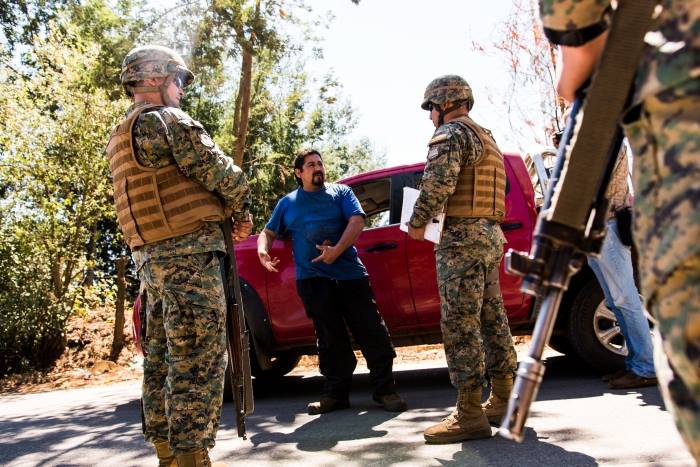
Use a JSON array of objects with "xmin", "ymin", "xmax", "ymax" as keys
[{"xmin": 409, "ymin": 117, "xmax": 503, "ymax": 254}]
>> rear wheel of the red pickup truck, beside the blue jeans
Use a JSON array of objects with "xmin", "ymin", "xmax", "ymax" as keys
[{"xmin": 567, "ymin": 278, "xmax": 627, "ymax": 373}]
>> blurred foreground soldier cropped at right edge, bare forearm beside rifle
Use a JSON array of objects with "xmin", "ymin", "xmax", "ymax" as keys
[{"xmin": 540, "ymin": 0, "xmax": 700, "ymax": 462}]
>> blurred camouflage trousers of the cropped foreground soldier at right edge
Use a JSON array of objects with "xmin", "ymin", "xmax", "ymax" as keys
[{"xmin": 625, "ymin": 86, "xmax": 700, "ymax": 462}]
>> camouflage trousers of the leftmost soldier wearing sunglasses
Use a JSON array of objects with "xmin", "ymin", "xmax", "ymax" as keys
[{"xmin": 139, "ymin": 252, "xmax": 226, "ymax": 454}]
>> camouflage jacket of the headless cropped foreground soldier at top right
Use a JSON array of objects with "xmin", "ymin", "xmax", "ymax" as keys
[{"xmin": 539, "ymin": 0, "xmax": 700, "ymax": 103}]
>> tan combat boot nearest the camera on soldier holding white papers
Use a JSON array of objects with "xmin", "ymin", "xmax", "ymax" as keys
[{"xmin": 423, "ymin": 388, "xmax": 491, "ymax": 444}]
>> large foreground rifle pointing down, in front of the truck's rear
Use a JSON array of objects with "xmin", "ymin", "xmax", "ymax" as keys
[{"xmin": 498, "ymin": 0, "xmax": 657, "ymax": 442}]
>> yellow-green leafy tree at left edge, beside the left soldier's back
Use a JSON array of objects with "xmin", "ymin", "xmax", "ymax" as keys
[{"xmin": 0, "ymin": 24, "xmax": 128, "ymax": 373}]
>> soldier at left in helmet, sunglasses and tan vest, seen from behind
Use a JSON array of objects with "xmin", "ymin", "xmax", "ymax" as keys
[{"xmin": 107, "ymin": 46, "xmax": 252, "ymax": 466}]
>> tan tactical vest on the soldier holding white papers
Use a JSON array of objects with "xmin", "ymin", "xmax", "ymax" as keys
[{"xmin": 446, "ymin": 116, "xmax": 506, "ymax": 222}]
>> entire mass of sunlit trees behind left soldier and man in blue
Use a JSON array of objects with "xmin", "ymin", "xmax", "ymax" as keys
[{"xmin": 0, "ymin": 0, "xmax": 383, "ymax": 375}]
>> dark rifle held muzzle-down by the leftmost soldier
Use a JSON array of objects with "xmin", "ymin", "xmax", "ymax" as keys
[{"xmin": 221, "ymin": 218, "xmax": 254, "ymax": 439}]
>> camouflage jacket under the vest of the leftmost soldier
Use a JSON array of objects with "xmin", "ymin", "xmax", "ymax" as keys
[{"xmin": 127, "ymin": 104, "xmax": 249, "ymax": 269}]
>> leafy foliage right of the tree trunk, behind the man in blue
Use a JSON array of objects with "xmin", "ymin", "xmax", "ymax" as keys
[{"xmin": 215, "ymin": 55, "xmax": 385, "ymax": 230}]
